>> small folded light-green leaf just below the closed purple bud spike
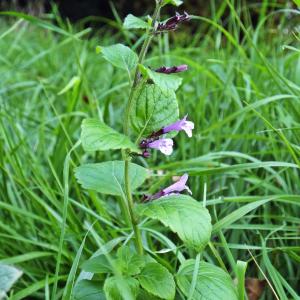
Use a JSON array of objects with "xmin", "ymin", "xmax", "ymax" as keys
[{"xmin": 139, "ymin": 65, "xmax": 182, "ymax": 92}]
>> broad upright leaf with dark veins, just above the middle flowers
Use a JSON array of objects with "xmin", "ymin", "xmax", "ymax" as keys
[{"xmin": 130, "ymin": 84, "xmax": 179, "ymax": 136}]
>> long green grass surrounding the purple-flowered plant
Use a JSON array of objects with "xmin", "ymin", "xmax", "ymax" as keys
[{"xmin": 0, "ymin": 1, "xmax": 300, "ymax": 299}]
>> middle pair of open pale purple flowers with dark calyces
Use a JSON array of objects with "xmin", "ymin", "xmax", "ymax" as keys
[{"xmin": 140, "ymin": 115, "xmax": 194, "ymax": 158}]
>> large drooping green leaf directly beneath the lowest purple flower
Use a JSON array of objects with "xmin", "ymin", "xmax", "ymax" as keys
[{"xmin": 137, "ymin": 195, "xmax": 212, "ymax": 251}]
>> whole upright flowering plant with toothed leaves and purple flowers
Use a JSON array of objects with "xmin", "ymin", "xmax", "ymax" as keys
[{"xmin": 75, "ymin": 0, "xmax": 237, "ymax": 300}]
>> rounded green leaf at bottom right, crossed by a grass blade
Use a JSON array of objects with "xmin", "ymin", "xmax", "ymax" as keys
[{"xmin": 176, "ymin": 259, "xmax": 238, "ymax": 300}]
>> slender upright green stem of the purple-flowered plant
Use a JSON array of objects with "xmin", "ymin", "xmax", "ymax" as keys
[{"xmin": 123, "ymin": 1, "xmax": 161, "ymax": 255}]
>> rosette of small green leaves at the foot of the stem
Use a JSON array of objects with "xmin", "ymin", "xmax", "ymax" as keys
[{"xmin": 82, "ymin": 246, "xmax": 175, "ymax": 300}]
